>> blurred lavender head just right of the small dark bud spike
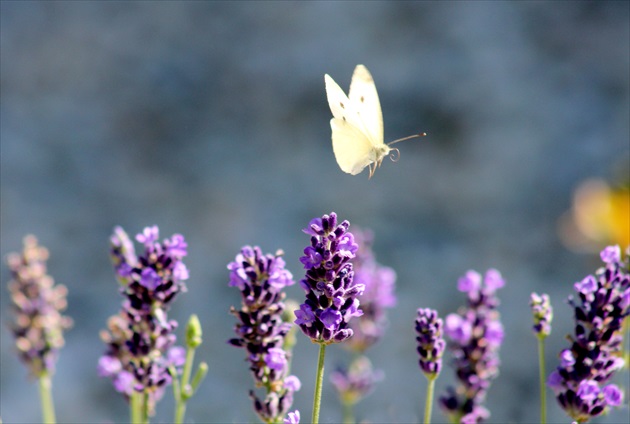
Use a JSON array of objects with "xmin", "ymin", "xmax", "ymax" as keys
[{"xmin": 440, "ymin": 269, "xmax": 504, "ymax": 423}]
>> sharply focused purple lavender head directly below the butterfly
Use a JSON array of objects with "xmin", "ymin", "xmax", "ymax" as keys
[{"xmin": 295, "ymin": 212, "xmax": 365, "ymax": 345}]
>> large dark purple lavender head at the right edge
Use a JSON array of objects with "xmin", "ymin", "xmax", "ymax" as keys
[{"xmin": 547, "ymin": 246, "xmax": 630, "ymax": 422}]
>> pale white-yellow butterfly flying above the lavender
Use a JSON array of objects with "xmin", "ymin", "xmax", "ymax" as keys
[{"xmin": 324, "ymin": 65, "xmax": 426, "ymax": 178}]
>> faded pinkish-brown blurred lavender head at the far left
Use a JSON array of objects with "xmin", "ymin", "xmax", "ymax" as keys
[{"xmin": 7, "ymin": 235, "xmax": 72, "ymax": 378}]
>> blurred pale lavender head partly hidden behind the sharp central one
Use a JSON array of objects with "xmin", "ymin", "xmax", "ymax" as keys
[{"xmin": 344, "ymin": 229, "xmax": 396, "ymax": 353}]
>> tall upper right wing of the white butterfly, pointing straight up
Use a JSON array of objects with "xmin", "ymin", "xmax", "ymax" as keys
[{"xmin": 348, "ymin": 65, "xmax": 384, "ymax": 147}]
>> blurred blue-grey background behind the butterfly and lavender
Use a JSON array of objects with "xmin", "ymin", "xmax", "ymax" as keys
[{"xmin": 0, "ymin": 1, "xmax": 630, "ymax": 423}]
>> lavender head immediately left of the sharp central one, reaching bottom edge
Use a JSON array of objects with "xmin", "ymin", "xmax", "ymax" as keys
[{"xmin": 228, "ymin": 246, "xmax": 300, "ymax": 423}]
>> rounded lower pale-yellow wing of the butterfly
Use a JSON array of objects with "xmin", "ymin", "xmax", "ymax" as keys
[{"xmin": 330, "ymin": 118, "xmax": 375, "ymax": 175}]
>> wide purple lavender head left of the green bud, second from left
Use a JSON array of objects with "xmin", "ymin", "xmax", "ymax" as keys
[{"xmin": 98, "ymin": 226, "xmax": 188, "ymax": 414}]
